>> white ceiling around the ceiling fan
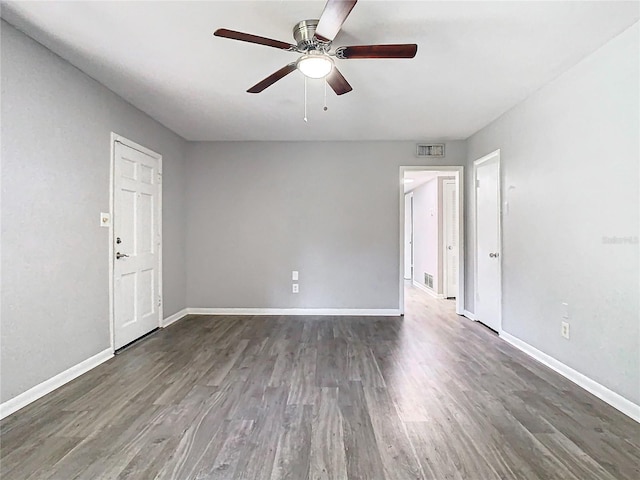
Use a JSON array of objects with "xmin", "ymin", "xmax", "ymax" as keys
[{"xmin": 2, "ymin": 0, "xmax": 639, "ymax": 140}]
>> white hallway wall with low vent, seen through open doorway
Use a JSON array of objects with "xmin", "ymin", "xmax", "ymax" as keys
[{"xmin": 413, "ymin": 177, "xmax": 440, "ymax": 292}]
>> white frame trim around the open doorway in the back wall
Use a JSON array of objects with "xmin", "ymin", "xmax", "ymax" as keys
[{"xmin": 398, "ymin": 165, "xmax": 464, "ymax": 315}]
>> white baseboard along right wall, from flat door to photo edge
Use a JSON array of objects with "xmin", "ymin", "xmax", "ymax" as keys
[{"xmin": 500, "ymin": 330, "xmax": 640, "ymax": 423}]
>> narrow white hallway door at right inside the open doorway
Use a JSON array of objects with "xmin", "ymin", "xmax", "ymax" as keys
[{"xmin": 442, "ymin": 180, "xmax": 458, "ymax": 298}]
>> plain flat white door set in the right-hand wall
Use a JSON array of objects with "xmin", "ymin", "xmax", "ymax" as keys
[{"xmin": 475, "ymin": 152, "xmax": 501, "ymax": 332}]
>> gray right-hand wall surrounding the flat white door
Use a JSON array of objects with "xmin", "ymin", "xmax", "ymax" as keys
[{"xmin": 466, "ymin": 24, "xmax": 640, "ymax": 403}]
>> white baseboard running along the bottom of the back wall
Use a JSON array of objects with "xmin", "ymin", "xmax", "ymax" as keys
[{"xmin": 186, "ymin": 308, "xmax": 400, "ymax": 317}]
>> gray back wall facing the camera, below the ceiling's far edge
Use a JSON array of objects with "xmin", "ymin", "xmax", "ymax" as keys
[{"xmin": 186, "ymin": 141, "xmax": 466, "ymax": 309}]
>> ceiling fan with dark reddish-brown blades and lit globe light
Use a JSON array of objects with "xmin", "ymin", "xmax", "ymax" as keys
[{"xmin": 214, "ymin": 0, "xmax": 418, "ymax": 95}]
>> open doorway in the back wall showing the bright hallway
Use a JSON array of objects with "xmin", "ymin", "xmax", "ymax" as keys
[{"xmin": 400, "ymin": 166, "xmax": 464, "ymax": 315}]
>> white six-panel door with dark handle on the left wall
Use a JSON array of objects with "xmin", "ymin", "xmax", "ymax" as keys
[{"xmin": 113, "ymin": 141, "xmax": 162, "ymax": 349}]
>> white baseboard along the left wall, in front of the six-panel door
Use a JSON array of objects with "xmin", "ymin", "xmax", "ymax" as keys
[{"xmin": 0, "ymin": 348, "xmax": 113, "ymax": 418}]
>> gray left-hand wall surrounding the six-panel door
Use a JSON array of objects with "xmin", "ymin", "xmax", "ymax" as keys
[{"xmin": 0, "ymin": 21, "xmax": 186, "ymax": 402}]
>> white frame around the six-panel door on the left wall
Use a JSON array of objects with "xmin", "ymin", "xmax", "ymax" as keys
[{"xmin": 109, "ymin": 132, "xmax": 164, "ymax": 352}]
